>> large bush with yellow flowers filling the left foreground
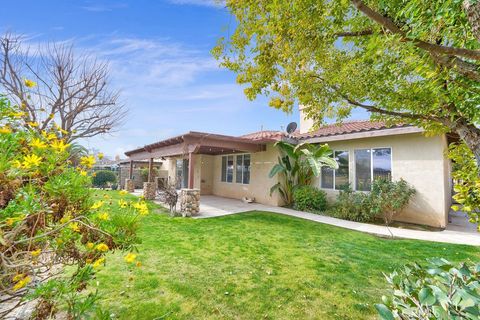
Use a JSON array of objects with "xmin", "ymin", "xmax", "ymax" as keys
[{"xmin": 0, "ymin": 96, "xmax": 149, "ymax": 319}]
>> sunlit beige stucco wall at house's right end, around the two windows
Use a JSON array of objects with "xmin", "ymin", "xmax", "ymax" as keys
[{"xmin": 314, "ymin": 133, "xmax": 451, "ymax": 227}]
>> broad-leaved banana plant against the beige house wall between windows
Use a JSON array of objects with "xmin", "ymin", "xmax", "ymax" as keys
[{"xmin": 269, "ymin": 141, "xmax": 338, "ymax": 205}]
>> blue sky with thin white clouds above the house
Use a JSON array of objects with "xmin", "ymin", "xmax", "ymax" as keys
[{"xmin": 0, "ymin": 0, "xmax": 366, "ymax": 157}]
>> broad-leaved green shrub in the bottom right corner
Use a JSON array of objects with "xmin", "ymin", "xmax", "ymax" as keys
[{"xmin": 375, "ymin": 258, "xmax": 480, "ymax": 320}]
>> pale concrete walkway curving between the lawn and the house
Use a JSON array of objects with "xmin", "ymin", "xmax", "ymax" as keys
[{"xmin": 135, "ymin": 191, "xmax": 480, "ymax": 246}]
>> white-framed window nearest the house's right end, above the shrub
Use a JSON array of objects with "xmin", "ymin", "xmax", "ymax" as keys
[{"xmin": 355, "ymin": 148, "xmax": 392, "ymax": 191}]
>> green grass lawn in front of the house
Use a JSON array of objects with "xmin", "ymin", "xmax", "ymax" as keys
[{"xmin": 97, "ymin": 192, "xmax": 480, "ymax": 319}]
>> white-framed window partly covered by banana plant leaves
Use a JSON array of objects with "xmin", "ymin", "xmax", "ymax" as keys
[{"xmin": 320, "ymin": 151, "xmax": 349, "ymax": 190}]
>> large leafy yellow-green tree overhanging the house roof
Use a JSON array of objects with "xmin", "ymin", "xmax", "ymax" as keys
[{"xmin": 213, "ymin": 0, "xmax": 480, "ymax": 163}]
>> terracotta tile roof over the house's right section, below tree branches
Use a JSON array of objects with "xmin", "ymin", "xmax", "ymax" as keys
[{"xmin": 296, "ymin": 120, "xmax": 408, "ymax": 139}]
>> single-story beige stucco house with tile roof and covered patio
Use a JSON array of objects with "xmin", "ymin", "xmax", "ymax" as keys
[{"xmin": 125, "ymin": 110, "xmax": 452, "ymax": 228}]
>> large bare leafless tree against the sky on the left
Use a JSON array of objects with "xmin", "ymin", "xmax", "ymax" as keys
[{"xmin": 0, "ymin": 34, "xmax": 126, "ymax": 141}]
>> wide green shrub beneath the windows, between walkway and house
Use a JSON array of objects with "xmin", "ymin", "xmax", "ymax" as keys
[{"xmin": 328, "ymin": 179, "xmax": 415, "ymax": 225}]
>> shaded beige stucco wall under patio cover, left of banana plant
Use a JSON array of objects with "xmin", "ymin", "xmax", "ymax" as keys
[{"xmin": 212, "ymin": 144, "xmax": 282, "ymax": 206}]
